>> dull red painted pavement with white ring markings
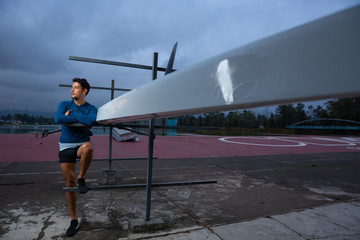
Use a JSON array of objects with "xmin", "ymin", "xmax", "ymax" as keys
[{"xmin": 0, "ymin": 133, "xmax": 360, "ymax": 162}]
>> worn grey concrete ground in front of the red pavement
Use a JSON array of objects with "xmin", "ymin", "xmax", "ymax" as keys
[{"xmin": 0, "ymin": 148, "xmax": 360, "ymax": 239}]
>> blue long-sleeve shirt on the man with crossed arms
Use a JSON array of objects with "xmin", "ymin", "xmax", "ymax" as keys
[{"xmin": 55, "ymin": 100, "xmax": 97, "ymax": 143}]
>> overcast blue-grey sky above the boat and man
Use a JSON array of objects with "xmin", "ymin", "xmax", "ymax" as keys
[{"xmin": 0, "ymin": 0, "xmax": 360, "ymax": 115}]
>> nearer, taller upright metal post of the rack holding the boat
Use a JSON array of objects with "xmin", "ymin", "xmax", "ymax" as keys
[{"xmin": 145, "ymin": 52, "xmax": 158, "ymax": 221}]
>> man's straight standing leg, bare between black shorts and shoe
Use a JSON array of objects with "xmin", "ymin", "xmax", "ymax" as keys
[{"xmin": 60, "ymin": 163, "xmax": 77, "ymax": 220}]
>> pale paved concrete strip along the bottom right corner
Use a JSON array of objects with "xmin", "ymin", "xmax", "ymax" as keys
[{"xmin": 119, "ymin": 201, "xmax": 360, "ymax": 240}]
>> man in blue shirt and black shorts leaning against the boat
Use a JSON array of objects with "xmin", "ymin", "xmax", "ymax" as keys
[{"xmin": 55, "ymin": 78, "xmax": 97, "ymax": 236}]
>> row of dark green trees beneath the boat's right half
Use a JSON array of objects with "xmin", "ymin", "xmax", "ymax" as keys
[{"xmin": 178, "ymin": 98, "xmax": 360, "ymax": 128}]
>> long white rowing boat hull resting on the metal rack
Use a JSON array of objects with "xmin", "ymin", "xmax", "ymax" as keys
[{"xmin": 97, "ymin": 6, "xmax": 360, "ymax": 124}]
